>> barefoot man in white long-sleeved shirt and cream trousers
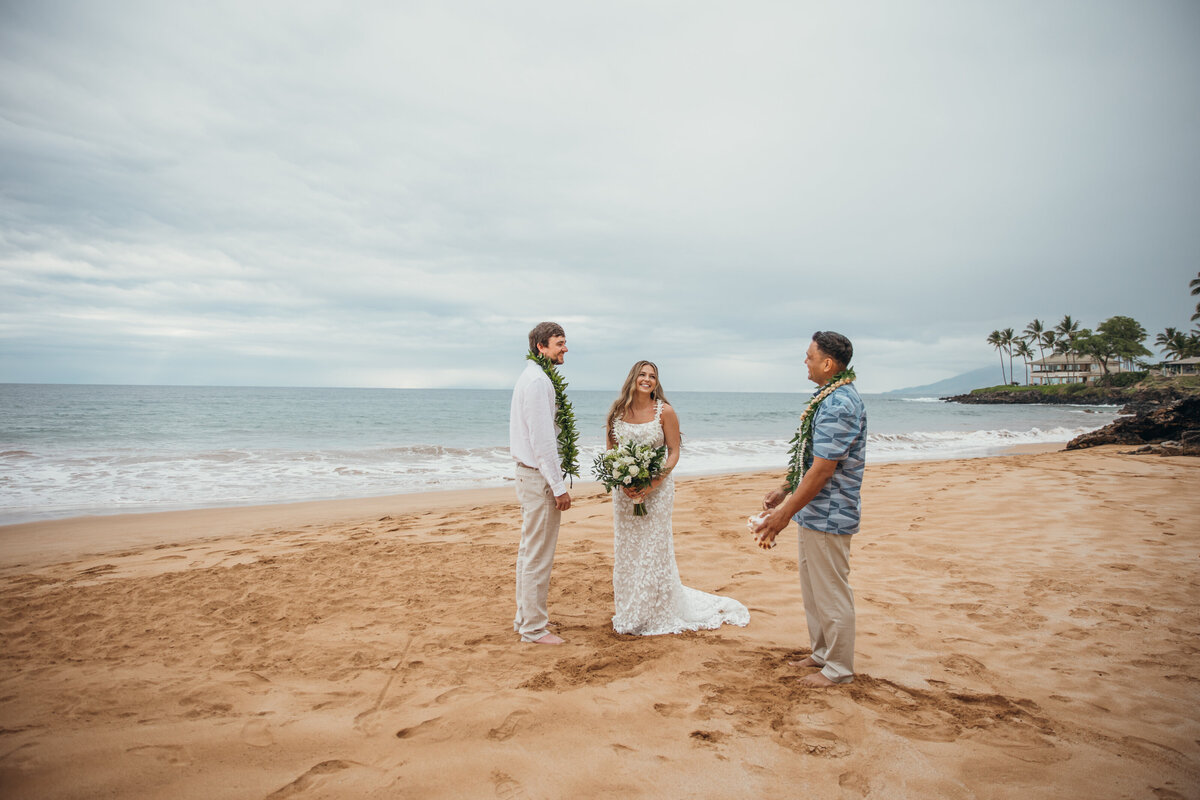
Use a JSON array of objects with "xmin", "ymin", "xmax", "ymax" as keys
[{"xmin": 509, "ymin": 323, "xmax": 571, "ymax": 644}]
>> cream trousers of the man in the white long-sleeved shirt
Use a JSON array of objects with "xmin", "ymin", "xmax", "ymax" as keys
[{"xmin": 512, "ymin": 464, "xmax": 563, "ymax": 642}]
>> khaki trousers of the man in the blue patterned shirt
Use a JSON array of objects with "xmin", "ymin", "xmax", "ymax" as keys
[{"xmin": 800, "ymin": 528, "xmax": 854, "ymax": 684}]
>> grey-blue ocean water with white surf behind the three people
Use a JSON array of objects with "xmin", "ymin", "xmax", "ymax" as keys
[{"xmin": 0, "ymin": 384, "xmax": 1117, "ymax": 524}]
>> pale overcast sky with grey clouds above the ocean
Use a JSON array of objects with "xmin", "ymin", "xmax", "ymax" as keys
[{"xmin": 0, "ymin": 0, "xmax": 1200, "ymax": 392}]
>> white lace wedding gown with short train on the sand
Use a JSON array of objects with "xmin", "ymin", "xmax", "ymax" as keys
[{"xmin": 612, "ymin": 401, "xmax": 750, "ymax": 636}]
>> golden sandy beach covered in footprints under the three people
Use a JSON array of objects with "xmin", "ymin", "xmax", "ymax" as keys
[{"xmin": 0, "ymin": 447, "xmax": 1200, "ymax": 800}]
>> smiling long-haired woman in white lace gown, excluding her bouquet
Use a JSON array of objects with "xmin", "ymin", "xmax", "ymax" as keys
[{"xmin": 606, "ymin": 361, "xmax": 750, "ymax": 636}]
